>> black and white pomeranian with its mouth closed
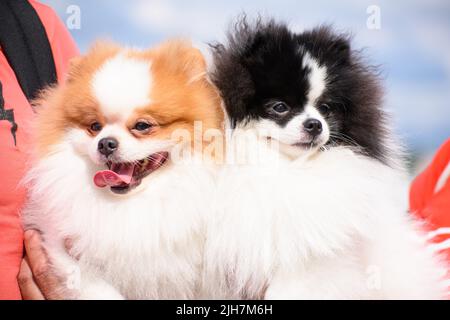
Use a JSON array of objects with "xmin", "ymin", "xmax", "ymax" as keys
[{"xmin": 204, "ymin": 18, "xmax": 445, "ymax": 299}]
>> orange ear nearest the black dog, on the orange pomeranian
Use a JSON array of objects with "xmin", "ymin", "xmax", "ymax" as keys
[{"xmin": 151, "ymin": 39, "xmax": 206, "ymax": 83}]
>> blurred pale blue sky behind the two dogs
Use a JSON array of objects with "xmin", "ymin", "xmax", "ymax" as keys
[{"xmin": 42, "ymin": 0, "xmax": 450, "ymax": 153}]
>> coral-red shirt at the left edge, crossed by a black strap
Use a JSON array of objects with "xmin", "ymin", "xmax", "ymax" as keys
[{"xmin": 0, "ymin": 0, "xmax": 78, "ymax": 299}]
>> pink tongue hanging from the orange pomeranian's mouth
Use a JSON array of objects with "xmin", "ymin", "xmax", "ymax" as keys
[{"xmin": 94, "ymin": 164, "xmax": 134, "ymax": 188}]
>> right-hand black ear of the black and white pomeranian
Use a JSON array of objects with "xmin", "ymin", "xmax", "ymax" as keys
[{"xmin": 298, "ymin": 26, "xmax": 351, "ymax": 64}]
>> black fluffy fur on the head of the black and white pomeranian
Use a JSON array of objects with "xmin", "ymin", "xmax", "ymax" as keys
[{"xmin": 211, "ymin": 17, "xmax": 390, "ymax": 163}]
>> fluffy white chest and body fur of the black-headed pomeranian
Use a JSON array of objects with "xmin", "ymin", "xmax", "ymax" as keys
[{"xmin": 204, "ymin": 129, "xmax": 444, "ymax": 299}]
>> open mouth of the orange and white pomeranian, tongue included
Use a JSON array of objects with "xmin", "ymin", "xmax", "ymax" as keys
[{"xmin": 94, "ymin": 152, "xmax": 169, "ymax": 194}]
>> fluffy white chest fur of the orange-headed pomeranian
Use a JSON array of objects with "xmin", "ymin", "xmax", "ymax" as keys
[{"xmin": 23, "ymin": 144, "xmax": 213, "ymax": 299}]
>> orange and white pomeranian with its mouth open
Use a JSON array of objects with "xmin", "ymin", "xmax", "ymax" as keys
[{"xmin": 22, "ymin": 40, "xmax": 223, "ymax": 299}]
